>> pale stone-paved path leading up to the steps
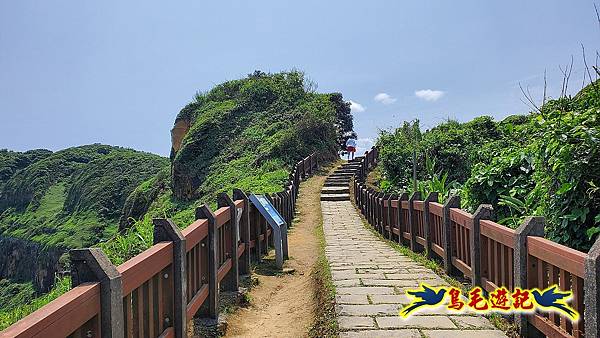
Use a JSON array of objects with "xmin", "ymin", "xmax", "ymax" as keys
[{"xmin": 321, "ymin": 168, "xmax": 505, "ymax": 338}]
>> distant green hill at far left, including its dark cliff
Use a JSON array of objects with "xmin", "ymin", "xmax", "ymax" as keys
[{"xmin": 0, "ymin": 144, "xmax": 169, "ymax": 298}]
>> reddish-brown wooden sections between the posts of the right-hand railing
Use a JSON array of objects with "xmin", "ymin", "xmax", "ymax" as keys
[{"xmin": 353, "ymin": 148, "xmax": 600, "ymax": 337}]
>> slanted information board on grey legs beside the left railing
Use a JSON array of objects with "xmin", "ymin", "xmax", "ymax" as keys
[{"xmin": 249, "ymin": 194, "xmax": 288, "ymax": 269}]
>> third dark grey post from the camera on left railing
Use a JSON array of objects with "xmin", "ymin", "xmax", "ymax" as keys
[{"xmin": 196, "ymin": 204, "xmax": 219, "ymax": 319}]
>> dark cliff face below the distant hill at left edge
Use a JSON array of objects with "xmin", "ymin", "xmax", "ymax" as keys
[{"xmin": 0, "ymin": 236, "xmax": 64, "ymax": 292}]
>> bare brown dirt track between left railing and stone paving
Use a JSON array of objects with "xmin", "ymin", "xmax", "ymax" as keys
[{"xmin": 226, "ymin": 175, "xmax": 325, "ymax": 337}]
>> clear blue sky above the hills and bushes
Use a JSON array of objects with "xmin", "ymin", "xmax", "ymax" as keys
[{"xmin": 0, "ymin": 0, "xmax": 600, "ymax": 155}]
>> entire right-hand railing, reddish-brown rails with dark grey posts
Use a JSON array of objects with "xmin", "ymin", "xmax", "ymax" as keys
[{"xmin": 352, "ymin": 148, "xmax": 600, "ymax": 337}]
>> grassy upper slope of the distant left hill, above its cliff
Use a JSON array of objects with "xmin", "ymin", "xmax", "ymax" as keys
[{"xmin": 0, "ymin": 144, "xmax": 168, "ymax": 249}]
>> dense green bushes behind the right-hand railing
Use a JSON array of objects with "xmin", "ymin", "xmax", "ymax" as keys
[{"xmin": 377, "ymin": 82, "xmax": 600, "ymax": 251}]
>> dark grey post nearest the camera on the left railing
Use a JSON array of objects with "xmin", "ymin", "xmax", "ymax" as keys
[{"xmin": 69, "ymin": 248, "xmax": 125, "ymax": 338}]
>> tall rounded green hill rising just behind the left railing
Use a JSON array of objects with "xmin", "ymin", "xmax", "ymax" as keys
[{"xmin": 117, "ymin": 71, "xmax": 352, "ymax": 238}]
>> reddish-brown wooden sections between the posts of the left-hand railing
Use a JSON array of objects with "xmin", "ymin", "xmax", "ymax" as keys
[{"xmin": 0, "ymin": 154, "xmax": 317, "ymax": 337}]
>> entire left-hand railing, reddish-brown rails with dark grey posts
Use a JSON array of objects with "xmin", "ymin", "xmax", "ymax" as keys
[{"xmin": 0, "ymin": 154, "xmax": 317, "ymax": 337}]
